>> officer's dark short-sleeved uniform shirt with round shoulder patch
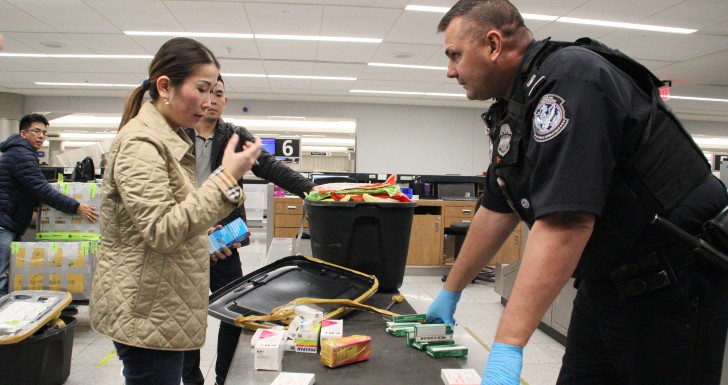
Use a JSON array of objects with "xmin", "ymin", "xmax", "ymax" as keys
[{"xmin": 482, "ymin": 44, "xmax": 651, "ymax": 225}]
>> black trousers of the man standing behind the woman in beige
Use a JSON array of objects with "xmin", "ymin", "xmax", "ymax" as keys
[{"xmin": 182, "ymin": 249, "xmax": 243, "ymax": 385}]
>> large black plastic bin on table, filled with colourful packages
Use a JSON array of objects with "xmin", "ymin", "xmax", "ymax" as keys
[{"xmin": 303, "ymin": 199, "xmax": 417, "ymax": 292}]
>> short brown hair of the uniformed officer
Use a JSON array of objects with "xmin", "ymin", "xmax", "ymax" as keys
[{"xmin": 437, "ymin": 0, "xmax": 526, "ymax": 37}]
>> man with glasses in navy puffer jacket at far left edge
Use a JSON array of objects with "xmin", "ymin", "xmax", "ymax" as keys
[{"xmin": 0, "ymin": 114, "xmax": 100, "ymax": 295}]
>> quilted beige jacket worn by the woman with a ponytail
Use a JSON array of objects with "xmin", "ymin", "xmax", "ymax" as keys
[{"xmin": 90, "ymin": 103, "xmax": 243, "ymax": 350}]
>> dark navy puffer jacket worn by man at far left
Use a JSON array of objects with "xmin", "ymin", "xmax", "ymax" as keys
[{"xmin": 0, "ymin": 134, "xmax": 79, "ymax": 234}]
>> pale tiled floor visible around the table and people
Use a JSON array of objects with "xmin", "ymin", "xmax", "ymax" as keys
[{"xmin": 66, "ymin": 225, "xmax": 564, "ymax": 385}]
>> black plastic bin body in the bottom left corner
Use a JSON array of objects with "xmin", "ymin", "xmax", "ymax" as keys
[{"xmin": 0, "ymin": 316, "xmax": 76, "ymax": 385}]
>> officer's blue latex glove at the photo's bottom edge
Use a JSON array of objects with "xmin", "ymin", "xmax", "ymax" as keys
[{"xmin": 480, "ymin": 342, "xmax": 523, "ymax": 385}]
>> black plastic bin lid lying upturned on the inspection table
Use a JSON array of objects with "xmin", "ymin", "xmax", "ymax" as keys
[{"xmin": 208, "ymin": 255, "xmax": 376, "ymax": 324}]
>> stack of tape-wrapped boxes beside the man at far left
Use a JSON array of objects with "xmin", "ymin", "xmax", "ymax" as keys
[{"xmin": 9, "ymin": 181, "xmax": 101, "ymax": 301}]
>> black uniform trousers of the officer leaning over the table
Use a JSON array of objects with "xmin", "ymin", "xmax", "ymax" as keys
[{"xmin": 557, "ymin": 264, "xmax": 728, "ymax": 385}]
